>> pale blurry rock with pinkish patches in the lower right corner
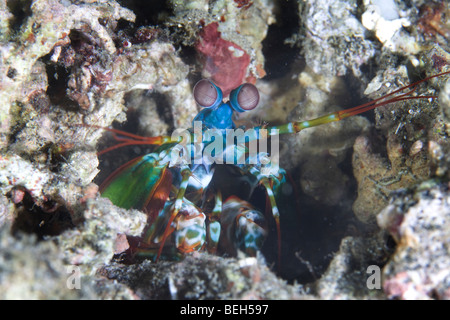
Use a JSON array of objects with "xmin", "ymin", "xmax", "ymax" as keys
[{"xmin": 377, "ymin": 181, "xmax": 450, "ymax": 300}]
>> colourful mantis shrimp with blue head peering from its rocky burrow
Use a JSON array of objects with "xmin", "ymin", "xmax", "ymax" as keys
[{"xmin": 94, "ymin": 71, "xmax": 450, "ymax": 262}]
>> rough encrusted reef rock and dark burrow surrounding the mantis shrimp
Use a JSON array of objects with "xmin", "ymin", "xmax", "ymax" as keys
[{"xmin": 0, "ymin": 0, "xmax": 450, "ymax": 299}]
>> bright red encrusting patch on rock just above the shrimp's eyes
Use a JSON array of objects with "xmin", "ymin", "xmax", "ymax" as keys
[{"xmin": 196, "ymin": 22, "xmax": 250, "ymax": 97}]
